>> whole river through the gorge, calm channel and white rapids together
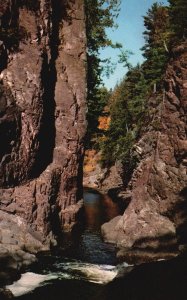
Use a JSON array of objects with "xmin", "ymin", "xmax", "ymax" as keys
[{"xmin": 6, "ymin": 190, "xmax": 126, "ymax": 300}]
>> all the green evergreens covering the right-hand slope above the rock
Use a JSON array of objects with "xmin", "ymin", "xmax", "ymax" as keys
[{"xmin": 93, "ymin": 0, "xmax": 187, "ymax": 183}]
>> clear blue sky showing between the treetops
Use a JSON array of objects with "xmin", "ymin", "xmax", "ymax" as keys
[{"xmin": 101, "ymin": 0, "xmax": 168, "ymax": 89}]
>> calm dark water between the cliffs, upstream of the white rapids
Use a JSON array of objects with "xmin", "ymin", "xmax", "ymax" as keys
[{"xmin": 60, "ymin": 190, "xmax": 119, "ymax": 265}]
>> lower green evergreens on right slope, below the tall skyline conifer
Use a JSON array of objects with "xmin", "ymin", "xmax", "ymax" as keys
[{"xmin": 101, "ymin": 65, "xmax": 148, "ymax": 172}]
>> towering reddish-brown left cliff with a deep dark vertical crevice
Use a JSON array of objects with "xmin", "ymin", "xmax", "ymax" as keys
[{"xmin": 0, "ymin": 0, "xmax": 86, "ymax": 276}]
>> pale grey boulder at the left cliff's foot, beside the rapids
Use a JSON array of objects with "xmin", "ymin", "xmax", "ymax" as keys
[{"xmin": 0, "ymin": 211, "xmax": 43, "ymax": 285}]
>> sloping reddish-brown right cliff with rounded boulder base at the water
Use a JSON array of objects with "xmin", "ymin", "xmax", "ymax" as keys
[{"xmin": 102, "ymin": 44, "xmax": 187, "ymax": 261}]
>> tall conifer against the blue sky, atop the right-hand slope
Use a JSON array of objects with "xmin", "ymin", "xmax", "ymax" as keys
[{"xmin": 142, "ymin": 3, "xmax": 170, "ymax": 91}]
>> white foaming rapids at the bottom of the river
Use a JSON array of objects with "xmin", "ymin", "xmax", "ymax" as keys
[{"xmin": 6, "ymin": 261, "xmax": 129, "ymax": 297}]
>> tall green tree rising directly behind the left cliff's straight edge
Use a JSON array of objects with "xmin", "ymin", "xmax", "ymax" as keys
[{"xmin": 85, "ymin": 0, "xmax": 121, "ymax": 146}]
